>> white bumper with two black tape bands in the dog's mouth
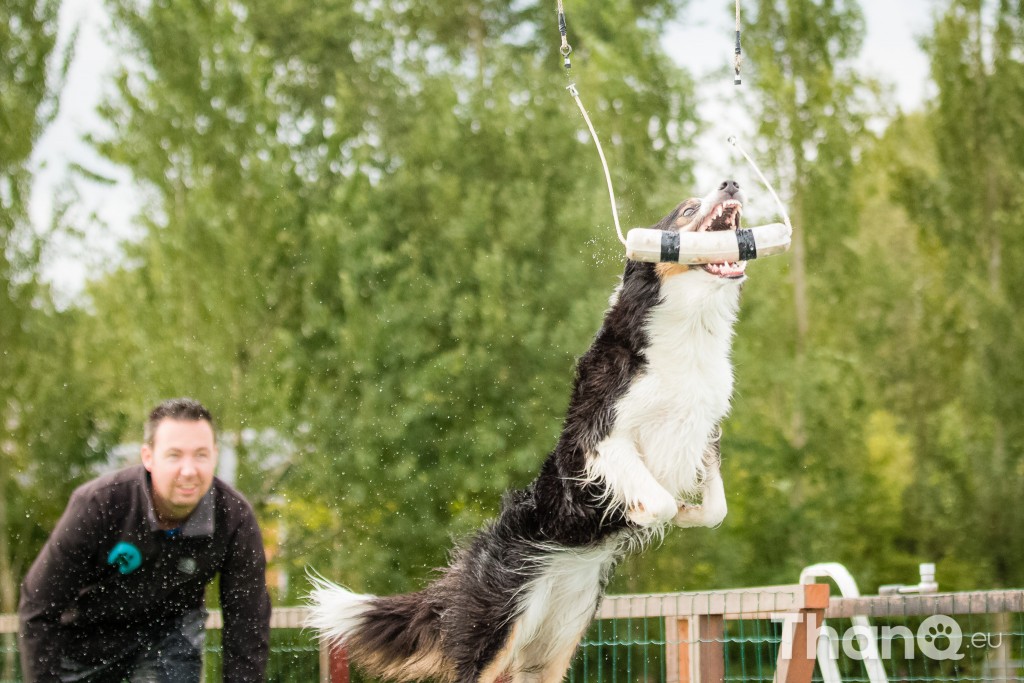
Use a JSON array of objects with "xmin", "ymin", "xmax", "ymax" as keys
[{"xmin": 626, "ymin": 223, "xmax": 793, "ymax": 265}]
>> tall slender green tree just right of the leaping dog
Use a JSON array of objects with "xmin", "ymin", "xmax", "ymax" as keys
[{"xmin": 734, "ymin": 0, "xmax": 870, "ymax": 579}]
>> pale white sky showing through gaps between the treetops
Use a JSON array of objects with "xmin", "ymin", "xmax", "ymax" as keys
[{"xmin": 30, "ymin": 0, "xmax": 938, "ymax": 301}]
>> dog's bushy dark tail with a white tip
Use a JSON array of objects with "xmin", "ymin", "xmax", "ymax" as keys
[{"xmin": 306, "ymin": 575, "xmax": 452, "ymax": 681}]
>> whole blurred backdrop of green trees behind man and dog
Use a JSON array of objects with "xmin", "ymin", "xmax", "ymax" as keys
[{"xmin": 6, "ymin": 0, "xmax": 1024, "ymax": 611}]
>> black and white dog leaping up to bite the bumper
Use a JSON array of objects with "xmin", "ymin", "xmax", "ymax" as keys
[{"xmin": 309, "ymin": 180, "xmax": 745, "ymax": 683}]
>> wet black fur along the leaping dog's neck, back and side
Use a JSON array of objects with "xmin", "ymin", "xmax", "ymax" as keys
[{"xmin": 335, "ymin": 250, "xmax": 676, "ymax": 683}]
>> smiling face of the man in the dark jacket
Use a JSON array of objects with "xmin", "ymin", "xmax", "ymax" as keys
[{"xmin": 142, "ymin": 418, "xmax": 217, "ymax": 522}]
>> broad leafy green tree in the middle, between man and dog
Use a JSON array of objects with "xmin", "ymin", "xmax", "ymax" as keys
[{"xmin": 83, "ymin": 0, "xmax": 692, "ymax": 595}]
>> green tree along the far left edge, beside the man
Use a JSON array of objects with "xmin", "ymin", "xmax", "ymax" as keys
[{"xmin": 0, "ymin": 0, "xmax": 117, "ymax": 679}]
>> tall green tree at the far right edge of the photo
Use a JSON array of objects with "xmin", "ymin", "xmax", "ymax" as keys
[{"xmin": 894, "ymin": 0, "xmax": 1024, "ymax": 586}]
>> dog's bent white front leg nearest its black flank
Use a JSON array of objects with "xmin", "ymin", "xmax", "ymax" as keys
[{"xmin": 587, "ymin": 435, "xmax": 679, "ymax": 526}]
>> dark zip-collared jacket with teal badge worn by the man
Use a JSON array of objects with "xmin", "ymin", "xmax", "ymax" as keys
[{"xmin": 18, "ymin": 465, "xmax": 270, "ymax": 682}]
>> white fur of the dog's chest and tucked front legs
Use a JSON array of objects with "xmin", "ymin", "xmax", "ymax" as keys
[{"xmin": 588, "ymin": 272, "xmax": 739, "ymax": 516}]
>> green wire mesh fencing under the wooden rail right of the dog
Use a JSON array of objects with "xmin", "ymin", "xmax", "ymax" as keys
[{"xmin": 566, "ymin": 593, "xmax": 1024, "ymax": 683}]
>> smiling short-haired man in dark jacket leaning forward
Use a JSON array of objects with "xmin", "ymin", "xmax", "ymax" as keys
[{"xmin": 18, "ymin": 398, "xmax": 270, "ymax": 683}]
